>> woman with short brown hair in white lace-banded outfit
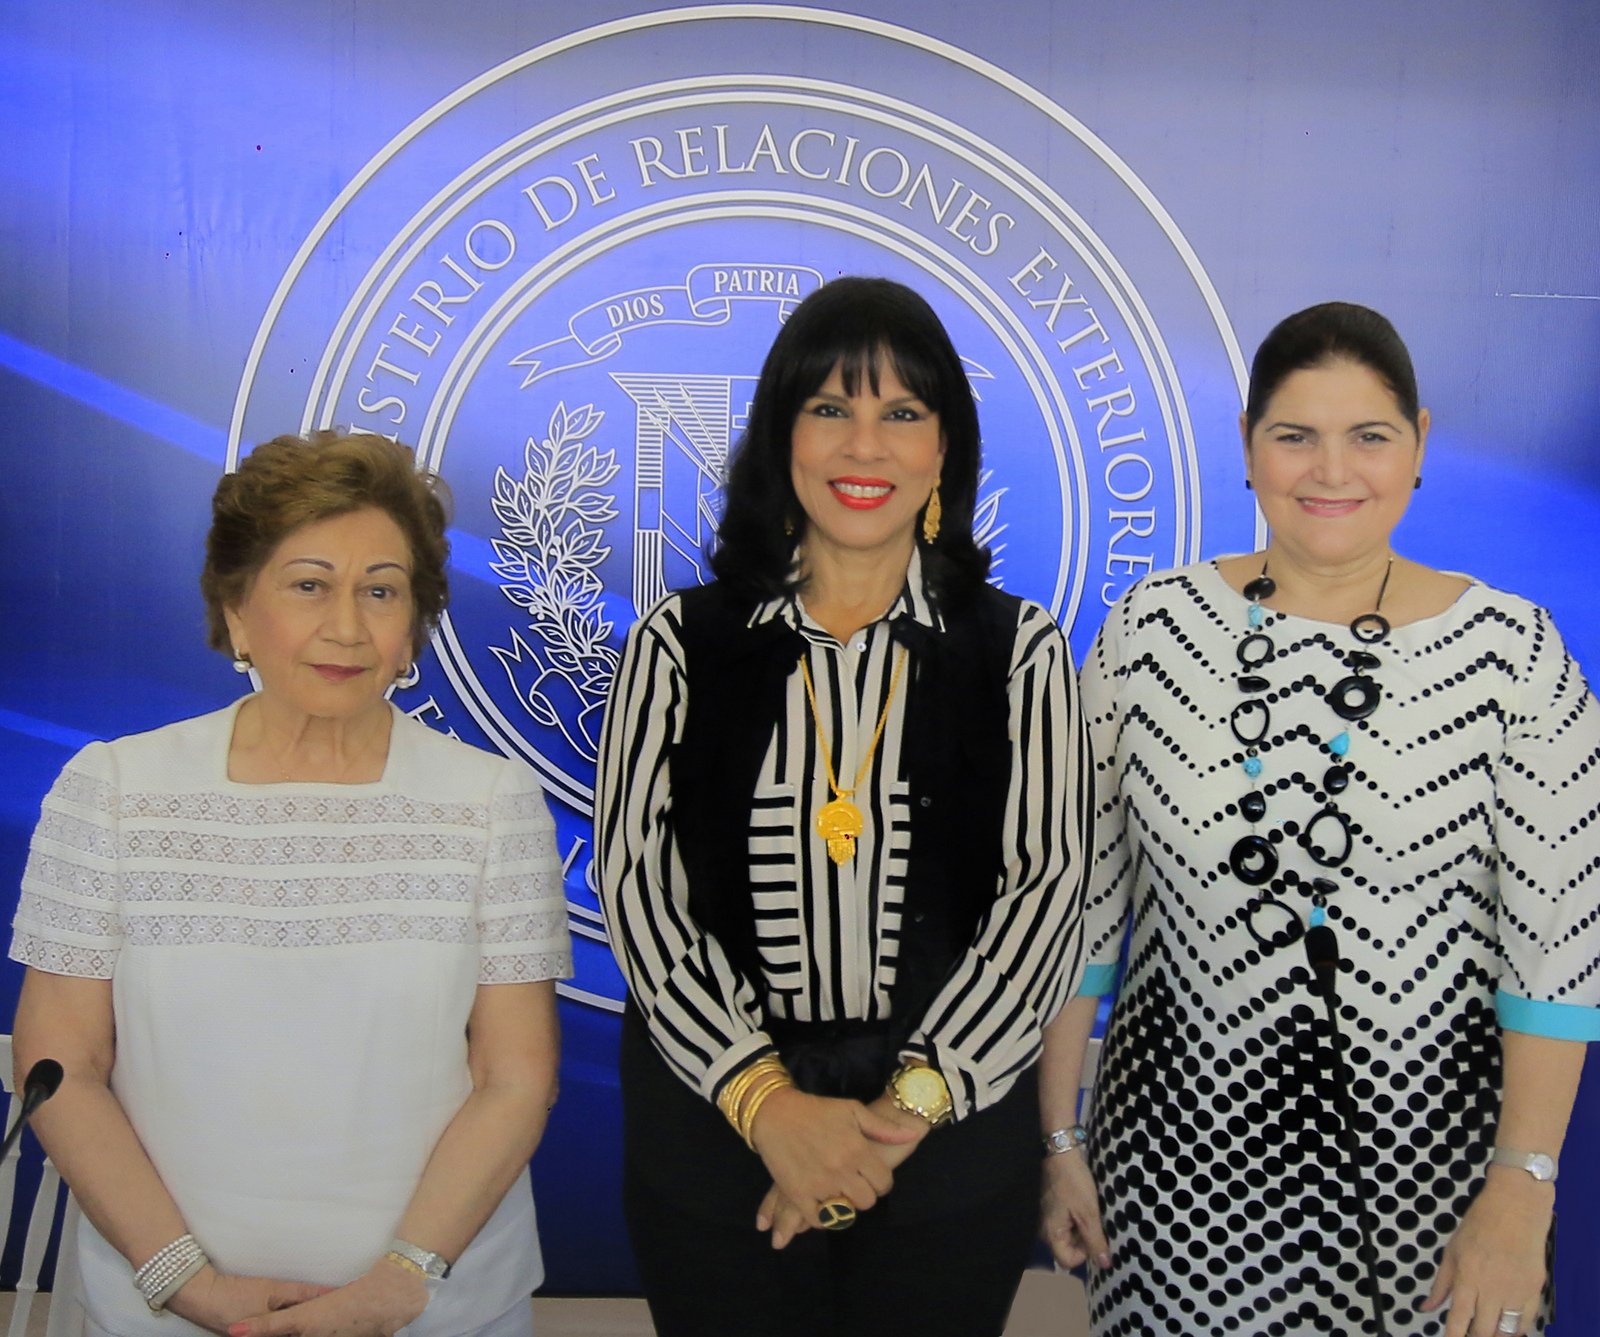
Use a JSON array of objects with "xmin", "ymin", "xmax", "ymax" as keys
[{"xmin": 11, "ymin": 432, "xmax": 570, "ymax": 1337}]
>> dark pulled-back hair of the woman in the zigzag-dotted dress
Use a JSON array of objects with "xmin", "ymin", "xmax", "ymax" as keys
[{"xmin": 1245, "ymin": 302, "xmax": 1421, "ymax": 432}]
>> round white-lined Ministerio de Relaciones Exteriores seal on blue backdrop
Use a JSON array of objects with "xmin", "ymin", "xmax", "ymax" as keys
[{"xmin": 229, "ymin": 5, "xmax": 1250, "ymax": 1008}]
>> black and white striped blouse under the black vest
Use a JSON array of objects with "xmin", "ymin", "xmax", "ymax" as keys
[{"xmin": 595, "ymin": 557, "xmax": 1093, "ymax": 1118}]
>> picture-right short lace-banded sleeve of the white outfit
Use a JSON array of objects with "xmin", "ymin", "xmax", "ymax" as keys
[{"xmin": 477, "ymin": 761, "xmax": 573, "ymax": 984}]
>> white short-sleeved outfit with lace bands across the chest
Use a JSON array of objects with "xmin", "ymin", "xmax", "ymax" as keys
[{"xmin": 11, "ymin": 704, "xmax": 571, "ymax": 1337}]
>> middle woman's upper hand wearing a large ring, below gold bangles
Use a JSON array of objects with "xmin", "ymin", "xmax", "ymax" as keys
[{"xmin": 750, "ymin": 1088, "xmax": 926, "ymax": 1214}]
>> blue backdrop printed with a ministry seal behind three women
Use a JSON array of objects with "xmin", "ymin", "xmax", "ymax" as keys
[{"xmin": 0, "ymin": 0, "xmax": 1600, "ymax": 1332}]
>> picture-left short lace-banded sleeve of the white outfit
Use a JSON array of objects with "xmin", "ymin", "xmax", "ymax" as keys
[{"xmin": 11, "ymin": 742, "xmax": 123, "ymax": 979}]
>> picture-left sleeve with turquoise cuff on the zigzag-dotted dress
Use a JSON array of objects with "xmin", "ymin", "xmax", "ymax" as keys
[{"xmin": 1077, "ymin": 592, "xmax": 1139, "ymax": 998}]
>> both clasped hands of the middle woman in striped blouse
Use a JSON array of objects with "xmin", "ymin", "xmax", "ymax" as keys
[{"xmin": 750, "ymin": 1089, "xmax": 930, "ymax": 1249}]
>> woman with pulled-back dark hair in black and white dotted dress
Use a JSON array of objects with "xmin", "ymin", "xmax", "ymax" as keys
[{"xmin": 1040, "ymin": 302, "xmax": 1600, "ymax": 1337}]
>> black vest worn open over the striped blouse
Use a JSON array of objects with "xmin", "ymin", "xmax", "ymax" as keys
[{"xmin": 669, "ymin": 584, "xmax": 1019, "ymax": 1028}]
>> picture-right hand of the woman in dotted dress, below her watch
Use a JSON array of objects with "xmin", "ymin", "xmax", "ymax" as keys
[{"xmin": 1421, "ymin": 1166, "xmax": 1555, "ymax": 1337}]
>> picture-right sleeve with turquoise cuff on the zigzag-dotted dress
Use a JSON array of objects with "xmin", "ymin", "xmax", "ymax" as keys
[{"xmin": 1494, "ymin": 609, "xmax": 1600, "ymax": 1040}]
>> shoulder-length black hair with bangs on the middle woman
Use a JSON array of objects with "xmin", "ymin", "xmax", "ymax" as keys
[{"xmin": 710, "ymin": 278, "xmax": 989, "ymax": 605}]
